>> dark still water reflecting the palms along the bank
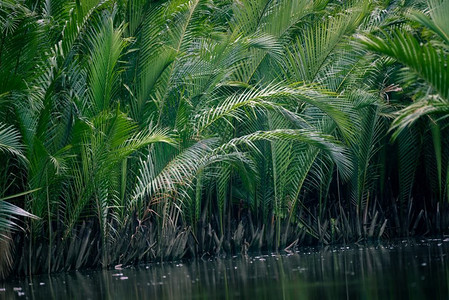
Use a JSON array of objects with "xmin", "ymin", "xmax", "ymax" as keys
[{"xmin": 0, "ymin": 239, "xmax": 449, "ymax": 300}]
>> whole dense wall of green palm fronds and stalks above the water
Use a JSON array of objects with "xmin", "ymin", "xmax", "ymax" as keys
[{"xmin": 0, "ymin": 0, "xmax": 449, "ymax": 275}]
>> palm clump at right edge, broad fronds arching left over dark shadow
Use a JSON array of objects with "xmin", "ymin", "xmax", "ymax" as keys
[{"xmin": 360, "ymin": 0, "xmax": 449, "ymax": 232}]
